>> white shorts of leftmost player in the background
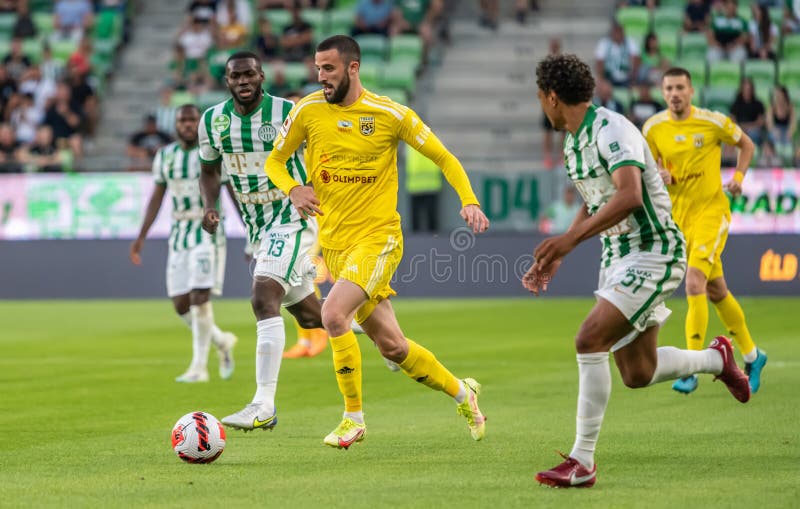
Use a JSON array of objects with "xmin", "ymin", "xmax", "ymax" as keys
[{"xmin": 167, "ymin": 243, "xmax": 225, "ymax": 297}]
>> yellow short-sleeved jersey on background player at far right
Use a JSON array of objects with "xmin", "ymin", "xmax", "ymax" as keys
[{"xmin": 642, "ymin": 106, "xmax": 742, "ymax": 228}]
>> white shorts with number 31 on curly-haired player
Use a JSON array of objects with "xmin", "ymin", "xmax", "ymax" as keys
[{"xmin": 594, "ymin": 253, "xmax": 686, "ymax": 352}]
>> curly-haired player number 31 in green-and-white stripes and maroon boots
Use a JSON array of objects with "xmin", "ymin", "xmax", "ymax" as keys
[{"xmin": 523, "ymin": 55, "xmax": 750, "ymax": 488}]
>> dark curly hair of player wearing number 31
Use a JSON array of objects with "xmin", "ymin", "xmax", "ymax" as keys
[{"xmin": 536, "ymin": 53, "xmax": 594, "ymax": 105}]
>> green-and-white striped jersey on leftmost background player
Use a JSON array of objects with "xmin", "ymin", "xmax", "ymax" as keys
[{"xmin": 153, "ymin": 142, "xmax": 228, "ymax": 251}]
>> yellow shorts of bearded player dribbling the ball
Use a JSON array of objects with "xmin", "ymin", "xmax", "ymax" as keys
[{"xmin": 322, "ymin": 234, "xmax": 403, "ymax": 323}]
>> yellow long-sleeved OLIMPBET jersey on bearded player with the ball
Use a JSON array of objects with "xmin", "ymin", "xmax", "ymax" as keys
[{"xmin": 265, "ymin": 90, "xmax": 478, "ymax": 250}]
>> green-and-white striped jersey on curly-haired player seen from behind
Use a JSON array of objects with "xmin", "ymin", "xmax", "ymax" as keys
[{"xmin": 564, "ymin": 105, "xmax": 685, "ymax": 267}]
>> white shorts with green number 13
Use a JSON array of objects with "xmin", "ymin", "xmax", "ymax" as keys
[{"xmin": 253, "ymin": 218, "xmax": 318, "ymax": 307}]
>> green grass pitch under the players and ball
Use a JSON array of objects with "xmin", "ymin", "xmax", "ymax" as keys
[{"xmin": 0, "ymin": 298, "xmax": 800, "ymax": 509}]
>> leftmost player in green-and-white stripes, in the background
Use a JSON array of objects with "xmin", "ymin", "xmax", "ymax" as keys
[{"xmin": 129, "ymin": 104, "xmax": 236, "ymax": 383}]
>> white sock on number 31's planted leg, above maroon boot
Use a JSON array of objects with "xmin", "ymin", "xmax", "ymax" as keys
[{"xmin": 569, "ymin": 352, "xmax": 611, "ymax": 470}]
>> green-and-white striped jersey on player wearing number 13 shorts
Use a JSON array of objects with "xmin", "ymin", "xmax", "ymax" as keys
[{"xmin": 199, "ymin": 92, "xmax": 307, "ymax": 243}]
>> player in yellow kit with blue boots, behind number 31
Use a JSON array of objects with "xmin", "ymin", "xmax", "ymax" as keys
[{"xmin": 642, "ymin": 68, "xmax": 767, "ymax": 394}]
